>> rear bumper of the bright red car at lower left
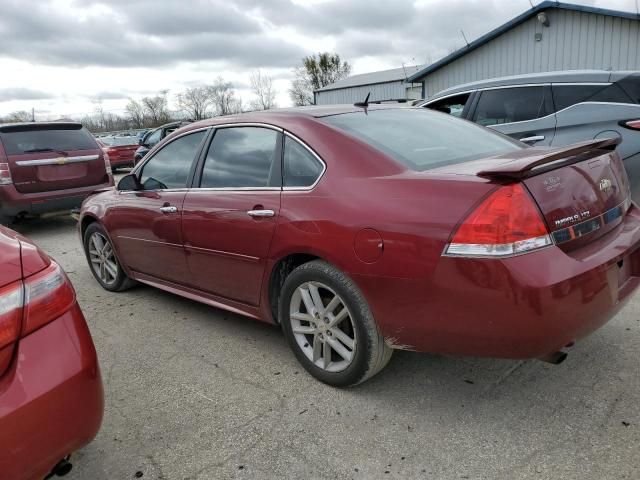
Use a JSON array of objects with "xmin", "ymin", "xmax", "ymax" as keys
[{"xmin": 0, "ymin": 305, "xmax": 104, "ymax": 480}]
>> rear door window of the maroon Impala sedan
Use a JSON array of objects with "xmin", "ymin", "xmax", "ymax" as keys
[{"xmin": 200, "ymin": 127, "xmax": 281, "ymax": 188}]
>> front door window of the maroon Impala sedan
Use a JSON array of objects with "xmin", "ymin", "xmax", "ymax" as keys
[{"xmin": 140, "ymin": 130, "xmax": 206, "ymax": 190}]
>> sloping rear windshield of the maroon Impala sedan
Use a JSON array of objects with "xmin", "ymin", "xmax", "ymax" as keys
[{"xmin": 322, "ymin": 108, "xmax": 523, "ymax": 171}]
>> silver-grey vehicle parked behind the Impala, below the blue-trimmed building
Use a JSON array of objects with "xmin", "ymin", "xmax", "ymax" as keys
[{"xmin": 421, "ymin": 70, "xmax": 640, "ymax": 202}]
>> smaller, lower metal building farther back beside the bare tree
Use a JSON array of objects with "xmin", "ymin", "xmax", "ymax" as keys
[{"xmin": 313, "ymin": 65, "xmax": 422, "ymax": 105}]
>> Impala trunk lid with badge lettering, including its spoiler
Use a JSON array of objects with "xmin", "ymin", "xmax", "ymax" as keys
[{"xmin": 477, "ymin": 139, "xmax": 631, "ymax": 250}]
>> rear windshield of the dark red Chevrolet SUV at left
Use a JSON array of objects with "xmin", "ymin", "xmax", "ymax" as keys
[{"xmin": 0, "ymin": 128, "xmax": 98, "ymax": 155}]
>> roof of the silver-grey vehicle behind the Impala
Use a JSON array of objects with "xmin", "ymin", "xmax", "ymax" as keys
[{"xmin": 426, "ymin": 70, "xmax": 636, "ymax": 102}]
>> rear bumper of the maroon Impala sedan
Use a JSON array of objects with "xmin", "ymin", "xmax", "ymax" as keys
[{"xmin": 354, "ymin": 207, "xmax": 640, "ymax": 358}]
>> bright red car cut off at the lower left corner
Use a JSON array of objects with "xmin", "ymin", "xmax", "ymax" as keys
[{"xmin": 0, "ymin": 227, "xmax": 103, "ymax": 480}]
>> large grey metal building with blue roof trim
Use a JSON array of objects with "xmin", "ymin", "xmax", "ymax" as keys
[{"xmin": 407, "ymin": 1, "xmax": 640, "ymax": 98}]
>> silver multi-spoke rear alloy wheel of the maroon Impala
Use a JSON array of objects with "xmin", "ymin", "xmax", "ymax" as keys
[{"xmin": 289, "ymin": 281, "xmax": 357, "ymax": 372}]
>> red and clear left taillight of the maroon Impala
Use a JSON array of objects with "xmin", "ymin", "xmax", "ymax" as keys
[{"xmin": 445, "ymin": 183, "xmax": 552, "ymax": 257}]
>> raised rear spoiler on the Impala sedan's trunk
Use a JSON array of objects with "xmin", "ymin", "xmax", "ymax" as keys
[{"xmin": 477, "ymin": 138, "xmax": 622, "ymax": 180}]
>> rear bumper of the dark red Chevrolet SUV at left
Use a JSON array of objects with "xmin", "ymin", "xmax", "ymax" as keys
[{"xmin": 0, "ymin": 178, "xmax": 113, "ymax": 217}]
